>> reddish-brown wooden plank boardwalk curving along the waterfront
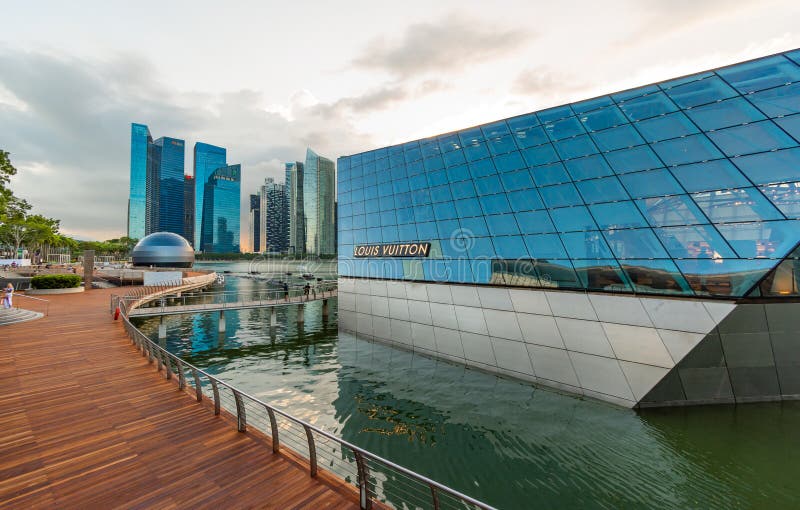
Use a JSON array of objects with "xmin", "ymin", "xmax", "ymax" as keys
[{"xmin": 0, "ymin": 289, "xmax": 358, "ymax": 509}]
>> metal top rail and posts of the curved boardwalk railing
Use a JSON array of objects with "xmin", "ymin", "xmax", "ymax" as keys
[{"xmin": 112, "ymin": 287, "xmax": 495, "ymax": 510}]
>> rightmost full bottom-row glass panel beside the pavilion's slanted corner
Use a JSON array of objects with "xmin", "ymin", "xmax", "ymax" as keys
[{"xmin": 677, "ymin": 259, "xmax": 774, "ymax": 296}]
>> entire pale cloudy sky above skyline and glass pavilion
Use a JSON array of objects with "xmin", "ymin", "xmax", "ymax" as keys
[{"xmin": 0, "ymin": 0, "xmax": 800, "ymax": 246}]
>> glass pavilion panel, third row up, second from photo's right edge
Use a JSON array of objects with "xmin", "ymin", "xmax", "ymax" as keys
[{"xmin": 692, "ymin": 188, "xmax": 783, "ymax": 223}]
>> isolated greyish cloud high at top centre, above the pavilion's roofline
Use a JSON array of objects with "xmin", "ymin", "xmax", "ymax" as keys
[{"xmin": 353, "ymin": 14, "xmax": 533, "ymax": 78}]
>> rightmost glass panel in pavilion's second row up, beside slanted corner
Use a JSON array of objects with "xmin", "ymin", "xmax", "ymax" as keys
[{"xmin": 717, "ymin": 220, "xmax": 800, "ymax": 259}]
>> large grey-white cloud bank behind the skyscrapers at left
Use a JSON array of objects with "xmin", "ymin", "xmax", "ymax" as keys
[{"xmin": 0, "ymin": 48, "xmax": 380, "ymax": 245}]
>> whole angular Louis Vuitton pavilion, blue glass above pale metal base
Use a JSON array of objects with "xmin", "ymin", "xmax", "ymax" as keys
[{"xmin": 338, "ymin": 50, "xmax": 800, "ymax": 407}]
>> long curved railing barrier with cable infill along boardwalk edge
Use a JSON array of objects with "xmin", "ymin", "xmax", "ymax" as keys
[{"xmin": 111, "ymin": 275, "xmax": 494, "ymax": 510}]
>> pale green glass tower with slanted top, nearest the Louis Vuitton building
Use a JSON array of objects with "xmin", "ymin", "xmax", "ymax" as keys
[{"xmin": 303, "ymin": 149, "xmax": 336, "ymax": 255}]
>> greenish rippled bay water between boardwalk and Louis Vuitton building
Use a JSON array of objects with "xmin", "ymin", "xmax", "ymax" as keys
[{"xmin": 133, "ymin": 263, "xmax": 800, "ymax": 508}]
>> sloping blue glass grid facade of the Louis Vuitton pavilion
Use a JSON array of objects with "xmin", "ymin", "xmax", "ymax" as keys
[{"xmin": 338, "ymin": 49, "xmax": 800, "ymax": 297}]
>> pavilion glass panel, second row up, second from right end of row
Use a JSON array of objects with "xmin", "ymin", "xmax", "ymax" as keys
[{"xmin": 655, "ymin": 225, "xmax": 736, "ymax": 259}]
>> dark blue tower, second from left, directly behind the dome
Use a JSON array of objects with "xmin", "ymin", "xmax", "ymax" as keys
[{"xmin": 145, "ymin": 137, "xmax": 184, "ymax": 235}]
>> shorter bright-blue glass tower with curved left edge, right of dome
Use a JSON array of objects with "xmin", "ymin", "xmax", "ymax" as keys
[{"xmin": 200, "ymin": 165, "xmax": 242, "ymax": 253}]
